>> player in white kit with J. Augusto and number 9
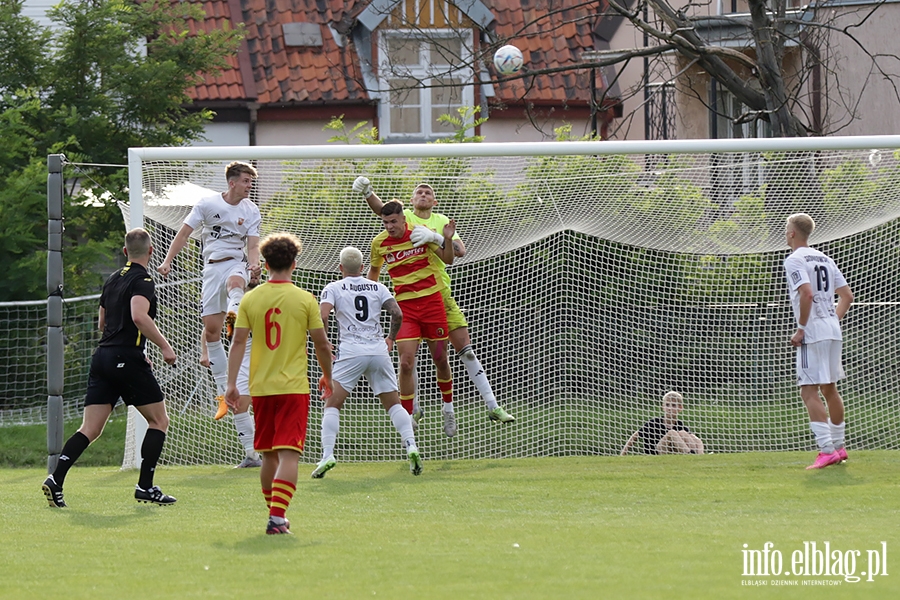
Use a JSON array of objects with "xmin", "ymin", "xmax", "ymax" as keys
[{"xmin": 312, "ymin": 247, "xmax": 422, "ymax": 479}]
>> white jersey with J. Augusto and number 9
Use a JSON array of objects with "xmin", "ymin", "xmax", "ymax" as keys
[{"xmin": 319, "ymin": 276, "xmax": 394, "ymax": 359}]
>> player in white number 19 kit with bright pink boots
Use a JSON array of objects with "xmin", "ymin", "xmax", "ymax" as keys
[{"xmin": 784, "ymin": 213, "xmax": 853, "ymax": 469}]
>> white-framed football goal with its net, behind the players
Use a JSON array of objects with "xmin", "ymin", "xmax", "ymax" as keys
[{"xmin": 122, "ymin": 136, "xmax": 900, "ymax": 466}]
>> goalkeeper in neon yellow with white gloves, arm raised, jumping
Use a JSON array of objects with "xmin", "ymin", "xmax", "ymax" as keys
[{"xmin": 353, "ymin": 177, "xmax": 516, "ymax": 437}]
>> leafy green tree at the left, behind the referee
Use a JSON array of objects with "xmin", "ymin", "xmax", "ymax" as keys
[{"xmin": 0, "ymin": 0, "xmax": 241, "ymax": 301}]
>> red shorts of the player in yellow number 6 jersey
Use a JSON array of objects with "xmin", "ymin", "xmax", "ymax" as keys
[{"xmin": 251, "ymin": 394, "xmax": 309, "ymax": 452}]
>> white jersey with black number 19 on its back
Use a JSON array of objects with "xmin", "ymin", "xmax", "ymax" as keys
[{"xmin": 784, "ymin": 246, "xmax": 847, "ymax": 344}]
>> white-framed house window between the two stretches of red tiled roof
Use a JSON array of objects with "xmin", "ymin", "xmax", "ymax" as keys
[{"xmin": 379, "ymin": 29, "xmax": 475, "ymax": 141}]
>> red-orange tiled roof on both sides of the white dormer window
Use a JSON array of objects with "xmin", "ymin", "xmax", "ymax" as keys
[{"xmin": 188, "ymin": 0, "xmax": 596, "ymax": 106}]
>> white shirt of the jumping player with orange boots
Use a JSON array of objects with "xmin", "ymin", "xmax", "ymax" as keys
[{"xmin": 184, "ymin": 194, "xmax": 261, "ymax": 262}]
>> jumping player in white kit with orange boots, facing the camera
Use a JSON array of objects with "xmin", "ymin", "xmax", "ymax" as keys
[{"xmin": 156, "ymin": 161, "xmax": 261, "ymax": 466}]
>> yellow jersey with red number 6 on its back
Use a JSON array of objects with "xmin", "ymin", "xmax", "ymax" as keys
[{"xmin": 235, "ymin": 281, "xmax": 324, "ymax": 396}]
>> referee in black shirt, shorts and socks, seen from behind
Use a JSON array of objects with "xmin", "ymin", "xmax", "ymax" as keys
[{"xmin": 41, "ymin": 228, "xmax": 177, "ymax": 508}]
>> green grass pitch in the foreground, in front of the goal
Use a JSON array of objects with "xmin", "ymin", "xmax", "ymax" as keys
[{"xmin": 0, "ymin": 451, "xmax": 900, "ymax": 600}]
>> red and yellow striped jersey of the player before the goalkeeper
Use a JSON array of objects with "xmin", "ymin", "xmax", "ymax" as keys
[{"xmin": 372, "ymin": 225, "xmax": 446, "ymax": 302}]
